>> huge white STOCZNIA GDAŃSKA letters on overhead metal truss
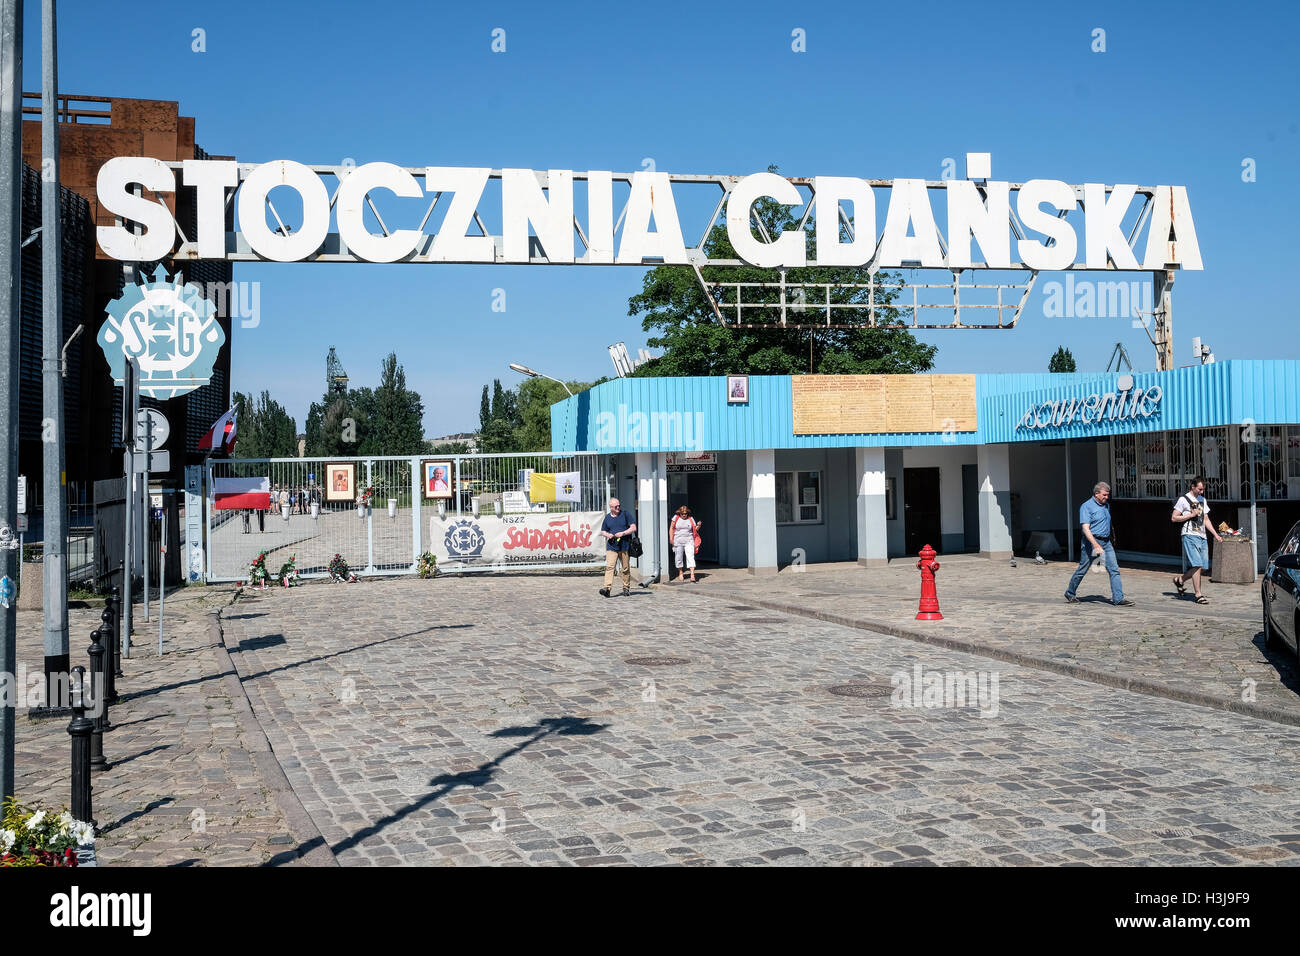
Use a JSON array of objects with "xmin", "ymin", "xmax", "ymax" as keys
[{"xmin": 96, "ymin": 156, "xmax": 1201, "ymax": 271}]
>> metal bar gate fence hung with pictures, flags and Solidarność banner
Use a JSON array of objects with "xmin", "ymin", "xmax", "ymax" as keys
[{"xmin": 204, "ymin": 453, "xmax": 610, "ymax": 581}]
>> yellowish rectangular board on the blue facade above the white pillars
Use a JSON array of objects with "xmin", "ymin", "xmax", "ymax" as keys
[{"xmin": 790, "ymin": 375, "xmax": 976, "ymax": 434}]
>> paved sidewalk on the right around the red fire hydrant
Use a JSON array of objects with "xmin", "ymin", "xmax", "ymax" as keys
[{"xmin": 670, "ymin": 554, "xmax": 1300, "ymax": 726}]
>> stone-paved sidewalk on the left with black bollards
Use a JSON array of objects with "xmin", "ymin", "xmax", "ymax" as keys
[{"xmin": 16, "ymin": 587, "xmax": 333, "ymax": 866}]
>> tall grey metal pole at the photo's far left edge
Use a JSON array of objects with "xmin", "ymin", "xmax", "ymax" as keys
[{"xmin": 0, "ymin": 0, "xmax": 22, "ymax": 800}]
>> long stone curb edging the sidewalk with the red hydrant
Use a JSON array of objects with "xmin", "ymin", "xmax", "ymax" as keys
[{"xmin": 690, "ymin": 585, "xmax": 1300, "ymax": 727}]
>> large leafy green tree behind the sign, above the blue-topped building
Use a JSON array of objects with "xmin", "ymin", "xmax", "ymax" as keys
[{"xmin": 628, "ymin": 166, "xmax": 937, "ymax": 376}]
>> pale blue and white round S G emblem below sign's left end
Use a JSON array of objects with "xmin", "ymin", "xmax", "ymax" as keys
[{"xmin": 99, "ymin": 267, "xmax": 226, "ymax": 399}]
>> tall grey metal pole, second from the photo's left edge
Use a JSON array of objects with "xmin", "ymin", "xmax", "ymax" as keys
[{"xmin": 40, "ymin": 0, "xmax": 68, "ymax": 708}]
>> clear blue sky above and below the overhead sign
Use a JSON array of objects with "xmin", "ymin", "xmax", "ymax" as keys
[{"xmin": 25, "ymin": 0, "xmax": 1300, "ymax": 437}]
